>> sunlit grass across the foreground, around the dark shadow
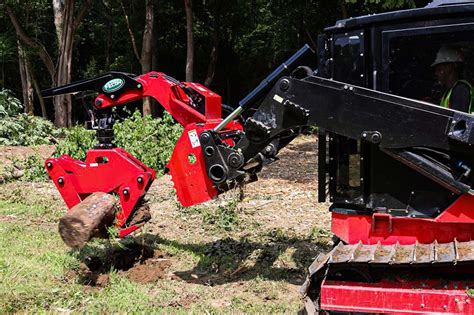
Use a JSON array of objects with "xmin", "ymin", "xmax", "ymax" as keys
[{"xmin": 0, "ymin": 200, "xmax": 301, "ymax": 314}]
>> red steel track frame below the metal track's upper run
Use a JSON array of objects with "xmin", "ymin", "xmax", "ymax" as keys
[{"xmin": 321, "ymin": 280, "xmax": 474, "ymax": 314}]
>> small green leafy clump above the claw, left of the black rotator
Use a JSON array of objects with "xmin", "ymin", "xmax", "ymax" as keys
[{"xmin": 53, "ymin": 126, "xmax": 96, "ymax": 160}]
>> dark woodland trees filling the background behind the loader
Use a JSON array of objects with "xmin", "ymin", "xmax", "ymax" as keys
[{"xmin": 0, "ymin": 0, "xmax": 428, "ymax": 126}]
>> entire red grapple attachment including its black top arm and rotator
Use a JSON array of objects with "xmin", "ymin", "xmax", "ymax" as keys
[{"xmin": 43, "ymin": 72, "xmax": 242, "ymax": 244}]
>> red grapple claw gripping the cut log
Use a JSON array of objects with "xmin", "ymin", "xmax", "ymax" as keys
[{"xmin": 45, "ymin": 148, "xmax": 156, "ymax": 237}]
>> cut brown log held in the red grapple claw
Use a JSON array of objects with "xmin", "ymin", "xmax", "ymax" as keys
[{"xmin": 59, "ymin": 192, "xmax": 116, "ymax": 249}]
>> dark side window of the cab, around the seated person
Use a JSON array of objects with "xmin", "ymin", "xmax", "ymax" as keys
[{"xmin": 388, "ymin": 30, "xmax": 474, "ymax": 104}]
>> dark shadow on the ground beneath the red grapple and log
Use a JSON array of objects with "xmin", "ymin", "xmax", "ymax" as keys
[{"xmin": 74, "ymin": 234, "xmax": 327, "ymax": 286}]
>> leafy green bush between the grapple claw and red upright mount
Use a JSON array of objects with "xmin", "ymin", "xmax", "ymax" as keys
[{"xmin": 114, "ymin": 111, "xmax": 183, "ymax": 174}]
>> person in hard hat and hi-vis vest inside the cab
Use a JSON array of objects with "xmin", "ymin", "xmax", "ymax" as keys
[{"xmin": 431, "ymin": 46, "xmax": 474, "ymax": 113}]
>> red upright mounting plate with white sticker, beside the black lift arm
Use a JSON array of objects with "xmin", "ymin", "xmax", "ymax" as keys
[{"xmin": 168, "ymin": 121, "xmax": 242, "ymax": 207}]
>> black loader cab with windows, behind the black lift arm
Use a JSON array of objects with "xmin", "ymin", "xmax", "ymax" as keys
[{"xmin": 318, "ymin": 1, "xmax": 474, "ymax": 217}]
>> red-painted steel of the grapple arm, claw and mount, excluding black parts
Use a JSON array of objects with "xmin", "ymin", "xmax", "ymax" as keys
[{"xmin": 45, "ymin": 72, "xmax": 242, "ymax": 237}]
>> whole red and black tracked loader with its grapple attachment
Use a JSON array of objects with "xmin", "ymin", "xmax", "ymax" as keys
[{"xmin": 44, "ymin": 1, "xmax": 474, "ymax": 314}]
